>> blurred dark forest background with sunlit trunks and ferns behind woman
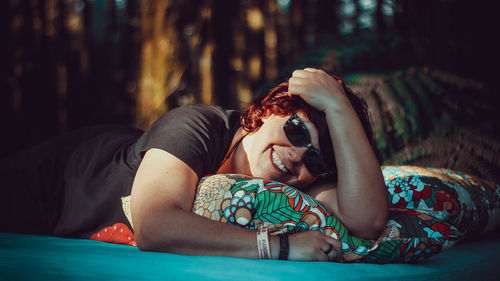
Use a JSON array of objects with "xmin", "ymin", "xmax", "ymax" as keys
[{"xmin": 0, "ymin": 0, "xmax": 500, "ymax": 181}]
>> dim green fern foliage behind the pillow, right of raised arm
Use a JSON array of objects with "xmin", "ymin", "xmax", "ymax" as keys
[{"xmin": 346, "ymin": 68, "xmax": 500, "ymax": 182}]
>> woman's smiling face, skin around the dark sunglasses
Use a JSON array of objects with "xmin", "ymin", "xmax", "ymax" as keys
[{"xmin": 243, "ymin": 112, "xmax": 319, "ymax": 188}]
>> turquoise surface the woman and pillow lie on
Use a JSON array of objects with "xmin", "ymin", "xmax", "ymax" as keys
[{"xmin": 0, "ymin": 233, "xmax": 500, "ymax": 281}]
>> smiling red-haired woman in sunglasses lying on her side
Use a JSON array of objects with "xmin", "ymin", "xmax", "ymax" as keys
[{"xmin": 1, "ymin": 68, "xmax": 387, "ymax": 260}]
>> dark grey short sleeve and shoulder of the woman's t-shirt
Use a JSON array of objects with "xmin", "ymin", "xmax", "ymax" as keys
[{"xmin": 135, "ymin": 105, "xmax": 240, "ymax": 177}]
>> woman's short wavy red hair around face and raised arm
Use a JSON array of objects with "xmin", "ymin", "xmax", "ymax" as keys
[{"xmin": 240, "ymin": 76, "xmax": 374, "ymax": 182}]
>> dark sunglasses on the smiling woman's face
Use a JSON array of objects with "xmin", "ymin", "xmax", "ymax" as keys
[{"xmin": 283, "ymin": 113, "xmax": 330, "ymax": 177}]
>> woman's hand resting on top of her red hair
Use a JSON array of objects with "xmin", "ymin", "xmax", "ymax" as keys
[{"xmin": 288, "ymin": 68, "xmax": 349, "ymax": 112}]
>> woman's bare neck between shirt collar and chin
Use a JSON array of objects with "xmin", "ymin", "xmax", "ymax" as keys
[{"xmin": 217, "ymin": 127, "xmax": 248, "ymax": 174}]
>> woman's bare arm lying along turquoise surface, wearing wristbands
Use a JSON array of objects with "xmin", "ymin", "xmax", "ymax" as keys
[{"xmin": 131, "ymin": 149, "xmax": 340, "ymax": 260}]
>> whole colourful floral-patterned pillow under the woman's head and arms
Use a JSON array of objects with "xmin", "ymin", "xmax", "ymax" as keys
[{"xmin": 193, "ymin": 166, "xmax": 500, "ymax": 263}]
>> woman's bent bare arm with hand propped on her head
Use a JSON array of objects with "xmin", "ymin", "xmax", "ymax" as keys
[{"xmin": 288, "ymin": 68, "xmax": 388, "ymax": 239}]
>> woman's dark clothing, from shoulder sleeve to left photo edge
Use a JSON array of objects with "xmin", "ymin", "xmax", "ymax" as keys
[{"xmin": 0, "ymin": 105, "xmax": 240, "ymax": 238}]
